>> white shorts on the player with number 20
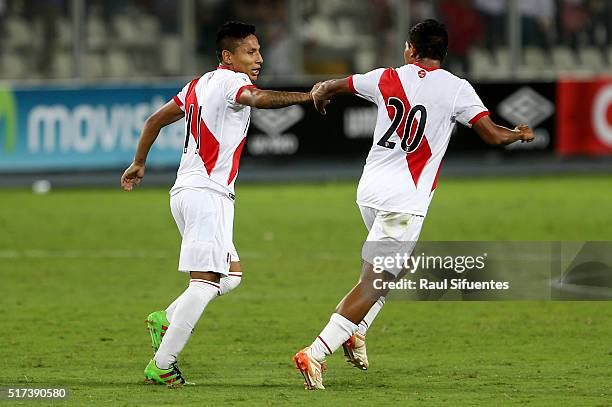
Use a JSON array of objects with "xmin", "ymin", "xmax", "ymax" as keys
[{"xmin": 359, "ymin": 205, "xmax": 425, "ymax": 277}]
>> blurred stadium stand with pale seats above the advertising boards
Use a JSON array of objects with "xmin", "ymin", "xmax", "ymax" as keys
[{"xmin": 0, "ymin": 0, "xmax": 612, "ymax": 188}]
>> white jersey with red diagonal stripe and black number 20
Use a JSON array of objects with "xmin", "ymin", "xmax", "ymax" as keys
[{"xmin": 349, "ymin": 64, "xmax": 489, "ymax": 216}]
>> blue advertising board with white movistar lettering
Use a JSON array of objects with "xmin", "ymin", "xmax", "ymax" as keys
[{"xmin": 0, "ymin": 84, "xmax": 184, "ymax": 173}]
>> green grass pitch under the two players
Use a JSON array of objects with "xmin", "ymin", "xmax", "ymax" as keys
[{"xmin": 0, "ymin": 176, "xmax": 612, "ymax": 406}]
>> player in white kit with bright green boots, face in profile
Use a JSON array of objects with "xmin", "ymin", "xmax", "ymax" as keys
[{"xmin": 121, "ymin": 22, "xmax": 316, "ymax": 386}]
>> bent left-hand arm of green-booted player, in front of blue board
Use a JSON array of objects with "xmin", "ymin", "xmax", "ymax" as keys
[{"xmin": 121, "ymin": 100, "xmax": 185, "ymax": 191}]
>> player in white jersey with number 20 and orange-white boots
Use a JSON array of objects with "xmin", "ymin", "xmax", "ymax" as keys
[{"xmin": 293, "ymin": 20, "xmax": 534, "ymax": 390}]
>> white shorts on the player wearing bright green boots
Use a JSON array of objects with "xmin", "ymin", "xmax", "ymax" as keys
[{"xmin": 170, "ymin": 188, "xmax": 239, "ymax": 275}]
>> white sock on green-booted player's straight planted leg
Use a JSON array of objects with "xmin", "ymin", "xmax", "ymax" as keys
[{"xmin": 155, "ymin": 278, "xmax": 219, "ymax": 369}]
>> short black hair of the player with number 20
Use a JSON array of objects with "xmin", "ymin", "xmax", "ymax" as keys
[{"xmin": 409, "ymin": 19, "xmax": 448, "ymax": 62}]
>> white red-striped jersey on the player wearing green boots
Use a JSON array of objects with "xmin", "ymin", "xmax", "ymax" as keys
[{"xmin": 170, "ymin": 67, "xmax": 254, "ymax": 198}]
